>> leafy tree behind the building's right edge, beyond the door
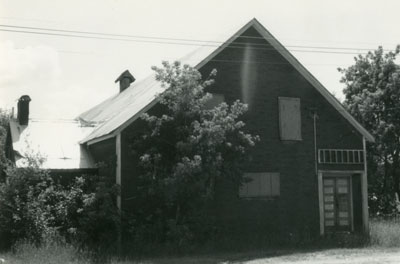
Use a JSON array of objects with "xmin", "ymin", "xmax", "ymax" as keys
[{"xmin": 339, "ymin": 46, "xmax": 400, "ymax": 213}]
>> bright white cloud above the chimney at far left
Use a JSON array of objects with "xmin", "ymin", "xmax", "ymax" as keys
[{"xmin": 0, "ymin": 41, "xmax": 61, "ymax": 116}]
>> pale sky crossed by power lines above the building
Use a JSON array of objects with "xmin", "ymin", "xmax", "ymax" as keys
[{"xmin": 0, "ymin": 0, "xmax": 400, "ymax": 120}]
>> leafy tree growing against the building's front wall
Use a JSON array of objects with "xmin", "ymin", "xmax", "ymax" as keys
[{"xmin": 132, "ymin": 62, "xmax": 258, "ymax": 243}]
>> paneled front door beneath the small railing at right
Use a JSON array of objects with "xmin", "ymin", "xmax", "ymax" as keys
[{"xmin": 323, "ymin": 177, "xmax": 352, "ymax": 232}]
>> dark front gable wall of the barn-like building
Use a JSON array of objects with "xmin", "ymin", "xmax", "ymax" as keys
[{"xmin": 117, "ymin": 28, "xmax": 362, "ymax": 239}]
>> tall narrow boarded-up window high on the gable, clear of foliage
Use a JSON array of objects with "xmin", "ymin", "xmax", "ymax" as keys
[{"xmin": 279, "ymin": 97, "xmax": 301, "ymax": 140}]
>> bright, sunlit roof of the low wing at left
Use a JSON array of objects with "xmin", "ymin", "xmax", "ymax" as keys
[{"xmin": 10, "ymin": 120, "xmax": 95, "ymax": 169}]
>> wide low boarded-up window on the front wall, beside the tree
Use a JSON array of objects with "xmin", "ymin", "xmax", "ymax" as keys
[{"xmin": 239, "ymin": 172, "xmax": 280, "ymax": 198}]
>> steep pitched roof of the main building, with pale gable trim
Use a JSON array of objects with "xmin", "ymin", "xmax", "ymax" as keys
[{"xmin": 79, "ymin": 18, "xmax": 374, "ymax": 143}]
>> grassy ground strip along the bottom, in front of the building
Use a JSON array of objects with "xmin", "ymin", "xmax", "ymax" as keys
[{"xmin": 0, "ymin": 219, "xmax": 400, "ymax": 264}]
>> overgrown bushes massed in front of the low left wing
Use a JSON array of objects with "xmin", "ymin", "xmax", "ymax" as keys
[{"xmin": 0, "ymin": 166, "xmax": 119, "ymax": 252}]
